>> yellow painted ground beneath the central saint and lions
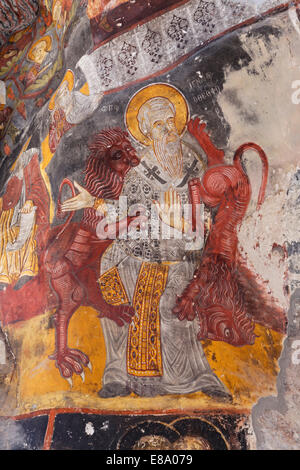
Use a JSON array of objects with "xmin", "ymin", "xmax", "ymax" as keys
[{"xmin": 1, "ymin": 307, "xmax": 283, "ymax": 415}]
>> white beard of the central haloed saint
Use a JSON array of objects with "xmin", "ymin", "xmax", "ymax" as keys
[{"xmin": 153, "ymin": 135, "xmax": 183, "ymax": 179}]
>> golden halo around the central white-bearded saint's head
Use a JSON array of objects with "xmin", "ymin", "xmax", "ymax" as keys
[{"xmin": 125, "ymin": 83, "xmax": 189, "ymax": 146}]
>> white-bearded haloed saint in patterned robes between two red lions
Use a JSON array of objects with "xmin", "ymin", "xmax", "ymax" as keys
[{"xmin": 99, "ymin": 84, "xmax": 231, "ymax": 400}]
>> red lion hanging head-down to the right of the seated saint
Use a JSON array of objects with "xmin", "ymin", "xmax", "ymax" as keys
[{"xmin": 173, "ymin": 118, "xmax": 286, "ymax": 346}]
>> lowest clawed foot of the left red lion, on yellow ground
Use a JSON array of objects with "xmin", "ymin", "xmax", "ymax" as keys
[{"xmin": 49, "ymin": 348, "xmax": 92, "ymax": 387}]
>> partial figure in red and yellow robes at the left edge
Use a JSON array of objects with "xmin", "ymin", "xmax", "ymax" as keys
[{"xmin": 0, "ymin": 141, "xmax": 49, "ymax": 290}]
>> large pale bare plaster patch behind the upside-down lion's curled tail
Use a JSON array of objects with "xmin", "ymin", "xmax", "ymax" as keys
[{"xmin": 218, "ymin": 12, "xmax": 300, "ymax": 308}]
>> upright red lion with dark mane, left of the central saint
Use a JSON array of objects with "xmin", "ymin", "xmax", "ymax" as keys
[{"xmin": 44, "ymin": 129, "xmax": 139, "ymax": 384}]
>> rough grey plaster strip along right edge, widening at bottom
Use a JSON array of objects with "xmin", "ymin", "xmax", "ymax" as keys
[{"xmin": 246, "ymin": 4, "xmax": 300, "ymax": 450}]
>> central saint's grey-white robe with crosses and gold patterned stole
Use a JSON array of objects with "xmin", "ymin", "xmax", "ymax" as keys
[{"xmin": 100, "ymin": 144, "xmax": 230, "ymax": 396}]
